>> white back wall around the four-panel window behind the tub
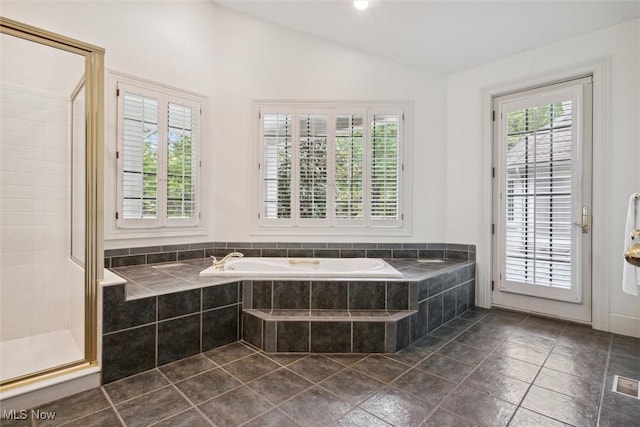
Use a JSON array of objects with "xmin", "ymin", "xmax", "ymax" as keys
[{"xmin": 211, "ymin": 5, "xmax": 446, "ymax": 242}]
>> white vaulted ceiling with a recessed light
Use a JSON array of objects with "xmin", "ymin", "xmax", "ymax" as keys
[{"xmin": 214, "ymin": 0, "xmax": 640, "ymax": 74}]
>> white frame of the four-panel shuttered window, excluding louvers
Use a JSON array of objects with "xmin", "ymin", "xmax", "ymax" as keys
[{"xmin": 252, "ymin": 101, "xmax": 412, "ymax": 236}]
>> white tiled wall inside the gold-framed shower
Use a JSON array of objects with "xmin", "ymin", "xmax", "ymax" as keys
[{"xmin": 0, "ymin": 85, "xmax": 71, "ymax": 341}]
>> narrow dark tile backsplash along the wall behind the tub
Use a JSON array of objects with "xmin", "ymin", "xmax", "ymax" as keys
[{"xmin": 104, "ymin": 242, "xmax": 476, "ymax": 268}]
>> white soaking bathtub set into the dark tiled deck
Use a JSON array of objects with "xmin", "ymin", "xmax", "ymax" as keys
[{"xmin": 200, "ymin": 257, "xmax": 402, "ymax": 278}]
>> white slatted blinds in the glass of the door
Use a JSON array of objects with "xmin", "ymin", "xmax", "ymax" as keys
[{"xmin": 505, "ymin": 100, "xmax": 574, "ymax": 289}]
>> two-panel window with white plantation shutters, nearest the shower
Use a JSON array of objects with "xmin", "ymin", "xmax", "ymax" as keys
[{"xmin": 116, "ymin": 78, "xmax": 201, "ymax": 228}]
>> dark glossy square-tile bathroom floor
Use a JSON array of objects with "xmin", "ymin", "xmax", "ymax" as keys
[{"xmin": 2, "ymin": 309, "xmax": 640, "ymax": 427}]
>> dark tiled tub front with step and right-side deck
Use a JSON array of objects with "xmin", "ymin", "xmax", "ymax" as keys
[{"xmin": 242, "ymin": 260, "xmax": 475, "ymax": 353}]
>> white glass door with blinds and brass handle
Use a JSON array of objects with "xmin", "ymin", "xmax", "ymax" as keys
[{"xmin": 492, "ymin": 77, "xmax": 592, "ymax": 322}]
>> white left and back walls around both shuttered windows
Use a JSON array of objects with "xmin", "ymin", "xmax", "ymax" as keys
[{"xmin": 3, "ymin": 1, "xmax": 446, "ymax": 249}]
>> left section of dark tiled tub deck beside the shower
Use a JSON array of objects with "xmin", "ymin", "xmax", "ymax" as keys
[{"xmin": 102, "ymin": 260, "xmax": 241, "ymax": 383}]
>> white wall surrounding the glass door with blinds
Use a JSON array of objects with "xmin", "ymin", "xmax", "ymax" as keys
[{"xmin": 446, "ymin": 20, "xmax": 640, "ymax": 336}]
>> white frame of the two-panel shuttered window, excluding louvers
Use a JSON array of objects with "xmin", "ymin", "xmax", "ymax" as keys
[{"xmin": 111, "ymin": 73, "xmax": 205, "ymax": 232}]
